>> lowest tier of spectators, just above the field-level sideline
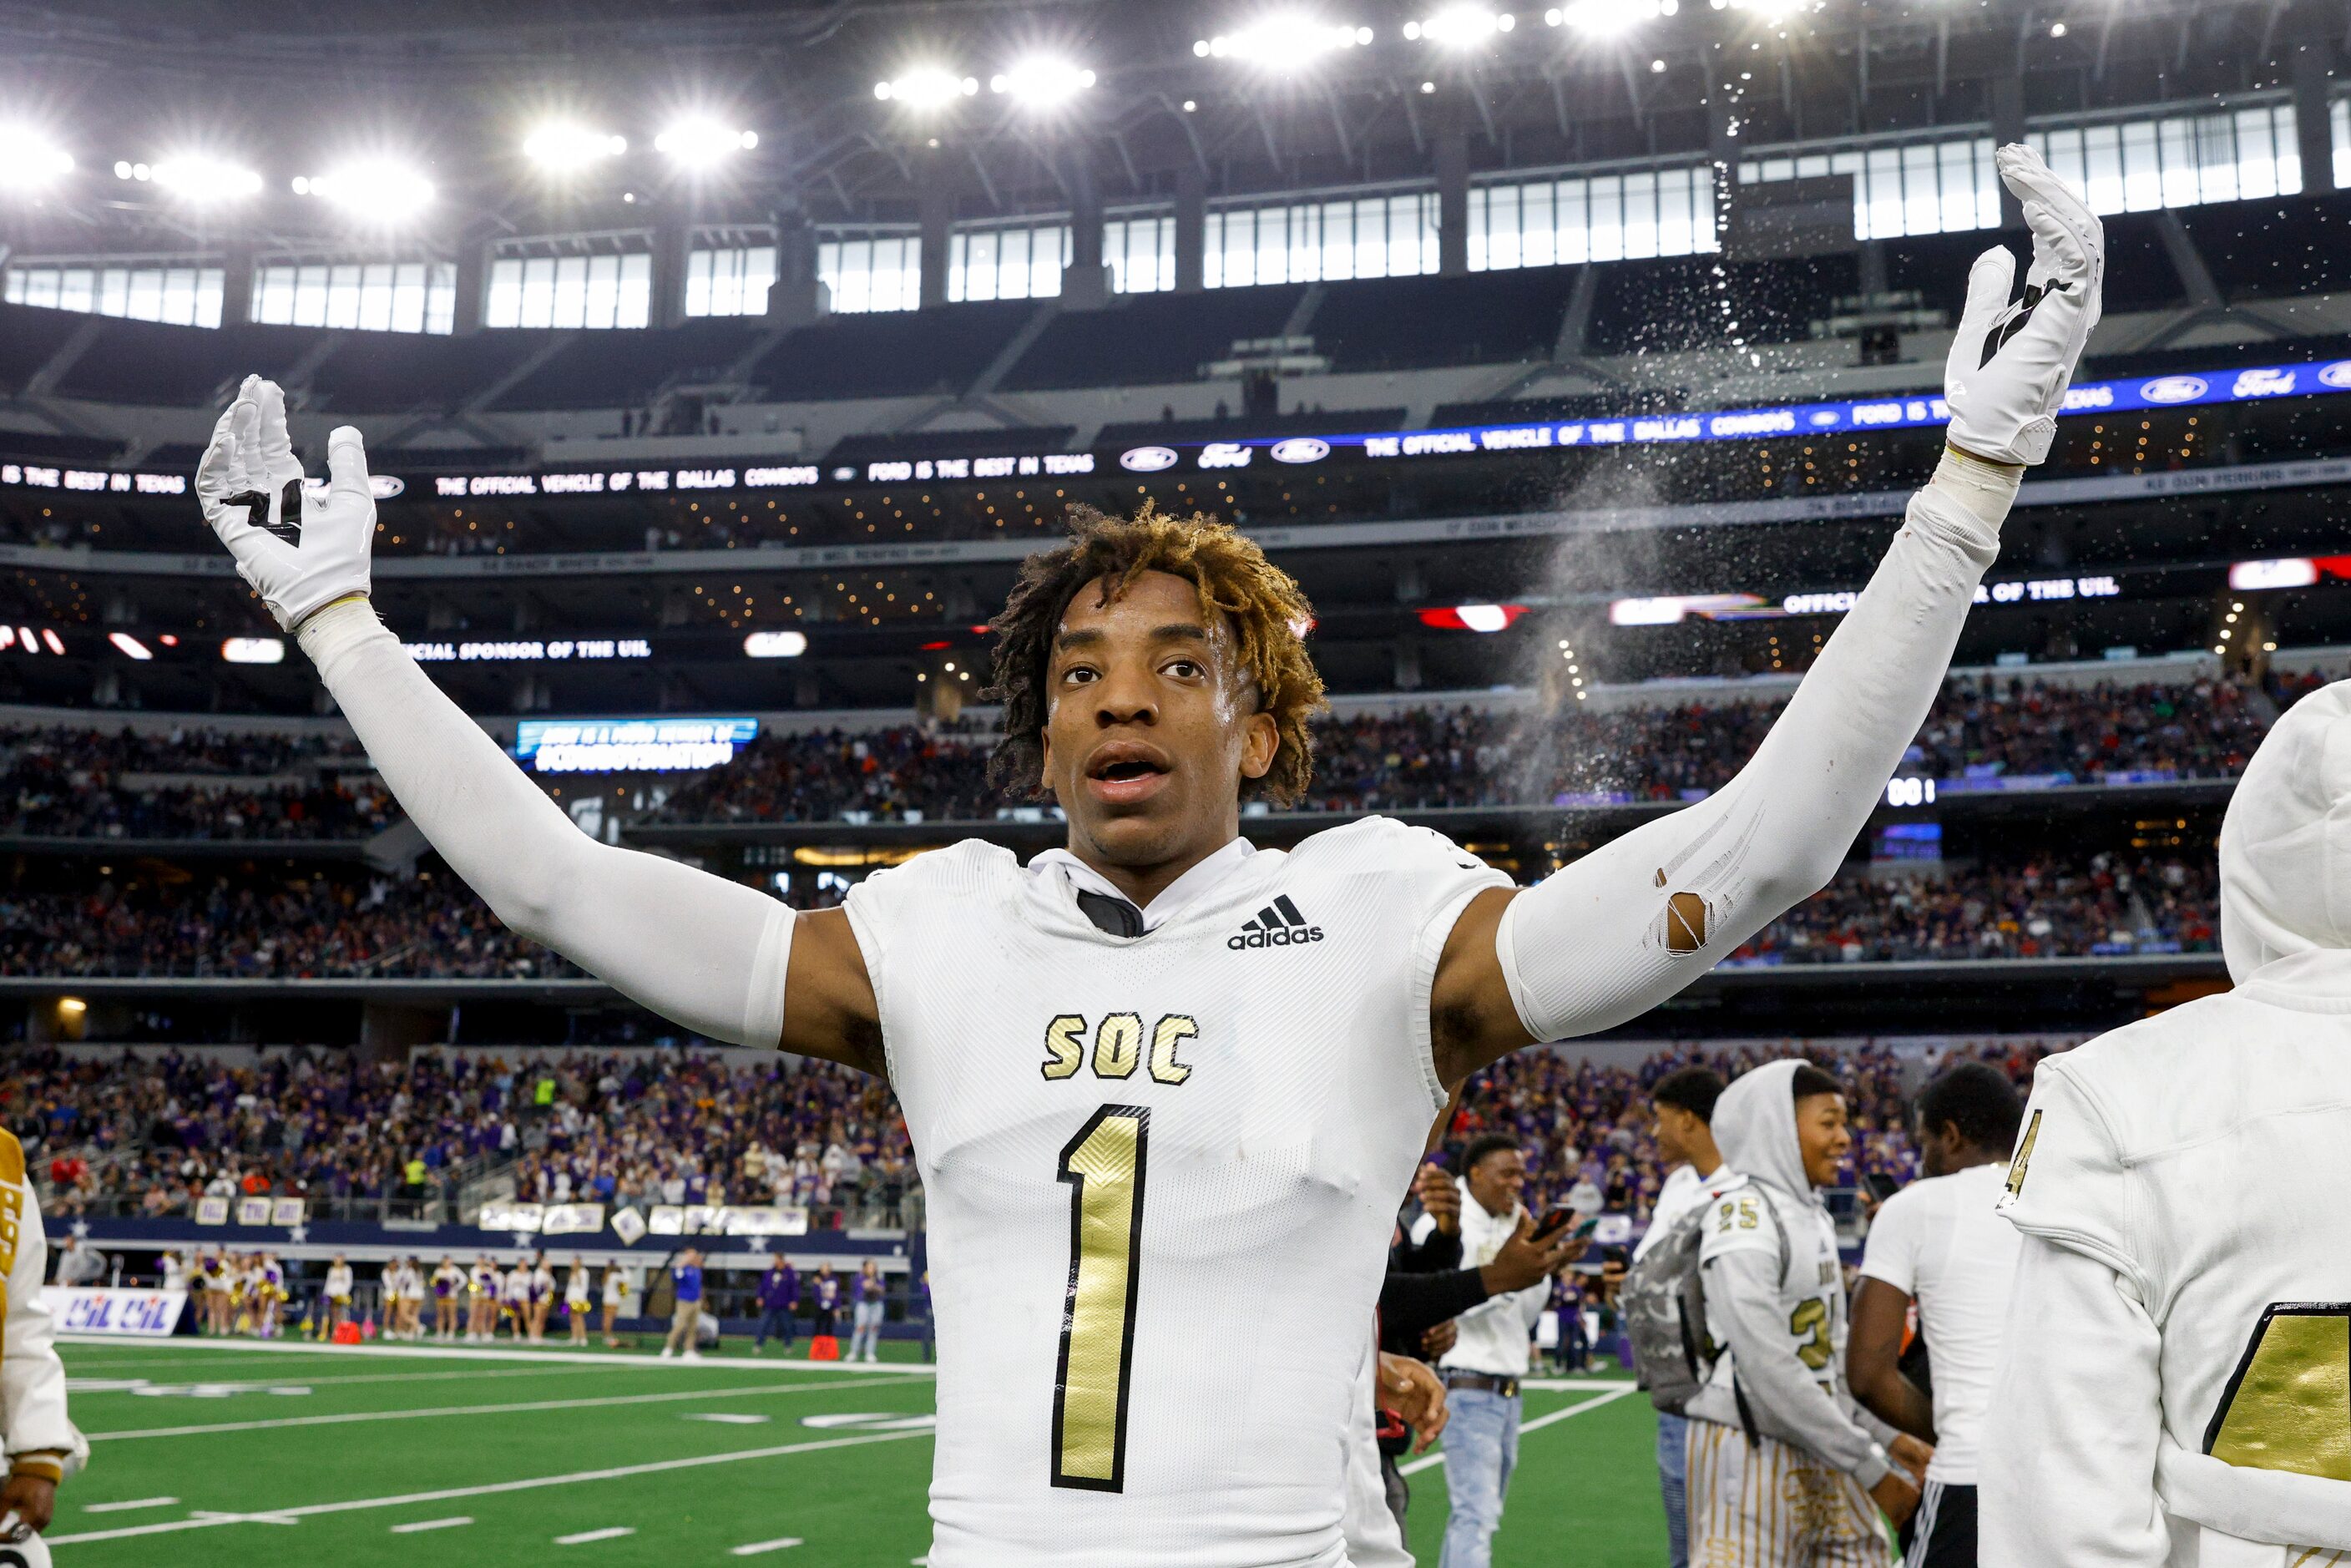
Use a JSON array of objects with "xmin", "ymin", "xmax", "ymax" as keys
[{"xmin": 13, "ymin": 1037, "xmax": 2048, "ymax": 1227}]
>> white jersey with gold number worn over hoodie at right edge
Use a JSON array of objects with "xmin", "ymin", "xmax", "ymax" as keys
[{"xmin": 1987, "ymin": 973, "xmax": 2351, "ymax": 1568}]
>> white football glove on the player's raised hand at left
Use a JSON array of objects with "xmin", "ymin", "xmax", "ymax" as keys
[{"xmin": 195, "ymin": 376, "xmax": 377, "ymax": 632}]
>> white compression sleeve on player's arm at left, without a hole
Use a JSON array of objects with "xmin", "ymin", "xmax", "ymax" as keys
[{"xmin": 299, "ymin": 599, "xmax": 792, "ymax": 1049}]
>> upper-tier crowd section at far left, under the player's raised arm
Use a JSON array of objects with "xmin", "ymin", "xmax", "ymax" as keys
[{"xmin": 0, "ymin": 726, "xmax": 397, "ymax": 839}]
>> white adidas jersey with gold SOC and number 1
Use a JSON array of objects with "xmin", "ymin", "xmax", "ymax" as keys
[{"xmin": 849, "ymin": 818, "xmax": 1509, "ymax": 1568}]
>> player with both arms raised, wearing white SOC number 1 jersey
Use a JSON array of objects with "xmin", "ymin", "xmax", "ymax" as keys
[{"xmin": 198, "ymin": 148, "xmax": 2102, "ymax": 1568}]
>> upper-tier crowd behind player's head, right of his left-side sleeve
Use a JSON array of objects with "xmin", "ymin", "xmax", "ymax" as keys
[{"xmin": 660, "ymin": 677, "xmax": 2318, "ymax": 822}]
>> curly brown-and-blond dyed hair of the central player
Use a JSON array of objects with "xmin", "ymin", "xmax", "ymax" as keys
[{"xmin": 980, "ymin": 501, "xmax": 1323, "ymax": 807}]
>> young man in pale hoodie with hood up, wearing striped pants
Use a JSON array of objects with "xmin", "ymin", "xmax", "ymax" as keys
[{"xmin": 1688, "ymin": 1060, "xmax": 1937, "ymax": 1568}]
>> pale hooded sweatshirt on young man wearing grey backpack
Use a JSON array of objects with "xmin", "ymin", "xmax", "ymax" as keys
[{"xmin": 1691, "ymin": 1058, "xmax": 1893, "ymax": 1485}]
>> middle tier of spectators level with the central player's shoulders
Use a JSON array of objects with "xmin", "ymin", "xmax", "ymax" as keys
[{"xmin": 0, "ymin": 851, "xmax": 2219, "ymax": 980}]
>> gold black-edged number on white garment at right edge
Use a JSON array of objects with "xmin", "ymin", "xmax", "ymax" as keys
[{"xmin": 2205, "ymin": 1302, "xmax": 2351, "ymax": 1481}]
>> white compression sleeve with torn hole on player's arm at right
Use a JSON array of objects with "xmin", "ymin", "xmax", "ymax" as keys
[{"xmin": 1495, "ymin": 452, "xmax": 2020, "ymax": 1039}]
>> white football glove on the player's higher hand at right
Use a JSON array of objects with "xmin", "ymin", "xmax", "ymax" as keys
[{"xmin": 1942, "ymin": 144, "xmax": 2106, "ymax": 463}]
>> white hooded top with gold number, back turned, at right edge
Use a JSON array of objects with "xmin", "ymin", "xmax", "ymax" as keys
[{"xmin": 1979, "ymin": 682, "xmax": 2351, "ymax": 1568}]
